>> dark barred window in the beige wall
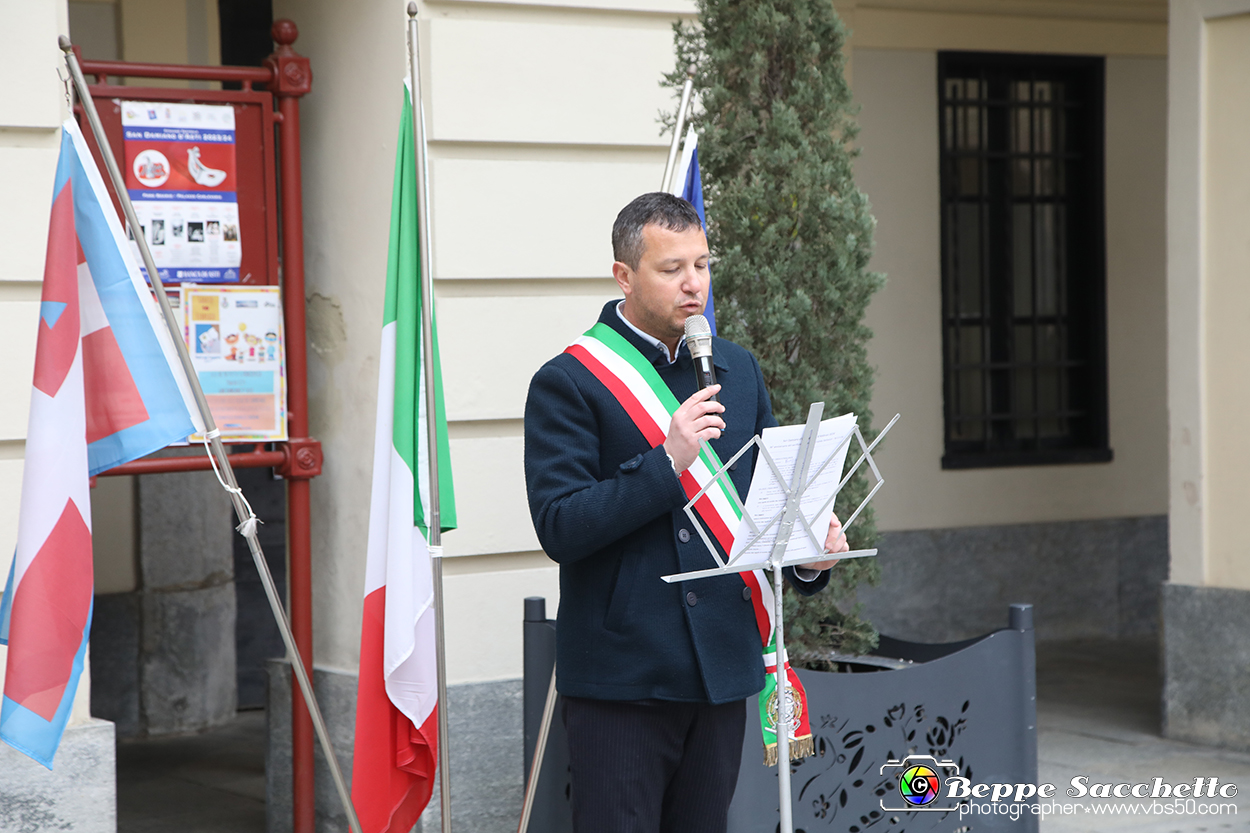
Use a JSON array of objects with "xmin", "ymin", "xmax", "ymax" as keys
[{"xmin": 938, "ymin": 53, "xmax": 1111, "ymax": 469}]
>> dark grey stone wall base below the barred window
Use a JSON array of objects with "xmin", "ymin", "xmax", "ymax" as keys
[{"xmin": 859, "ymin": 515, "xmax": 1168, "ymax": 642}]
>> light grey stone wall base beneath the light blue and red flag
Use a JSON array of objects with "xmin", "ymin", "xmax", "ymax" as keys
[{"xmin": 0, "ymin": 719, "xmax": 118, "ymax": 833}]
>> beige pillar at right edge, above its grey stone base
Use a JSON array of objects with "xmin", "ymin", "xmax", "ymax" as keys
[{"xmin": 1168, "ymin": 0, "xmax": 1250, "ymax": 590}]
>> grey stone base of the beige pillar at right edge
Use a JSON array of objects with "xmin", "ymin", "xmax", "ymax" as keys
[{"xmin": 1163, "ymin": 583, "xmax": 1250, "ymax": 752}]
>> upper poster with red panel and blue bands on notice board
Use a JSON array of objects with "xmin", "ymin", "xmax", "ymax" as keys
[{"xmin": 121, "ymin": 101, "xmax": 243, "ymax": 284}]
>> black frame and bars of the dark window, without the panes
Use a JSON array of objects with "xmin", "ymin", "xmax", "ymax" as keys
[{"xmin": 938, "ymin": 51, "xmax": 1114, "ymax": 469}]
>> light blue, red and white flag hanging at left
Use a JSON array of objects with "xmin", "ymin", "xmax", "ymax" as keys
[{"xmin": 0, "ymin": 119, "xmax": 203, "ymax": 768}]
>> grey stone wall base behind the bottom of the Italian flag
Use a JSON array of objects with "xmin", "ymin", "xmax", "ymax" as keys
[{"xmin": 265, "ymin": 659, "xmax": 524, "ymax": 833}]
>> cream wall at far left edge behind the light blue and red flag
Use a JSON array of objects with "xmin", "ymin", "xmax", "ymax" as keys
[{"xmin": 0, "ymin": 0, "xmax": 91, "ymax": 725}]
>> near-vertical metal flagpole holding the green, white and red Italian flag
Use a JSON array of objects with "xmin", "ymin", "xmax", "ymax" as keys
[{"xmin": 408, "ymin": 1, "xmax": 451, "ymax": 833}]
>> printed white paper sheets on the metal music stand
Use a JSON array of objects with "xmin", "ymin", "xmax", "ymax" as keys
[{"xmin": 730, "ymin": 414, "xmax": 855, "ymax": 564}]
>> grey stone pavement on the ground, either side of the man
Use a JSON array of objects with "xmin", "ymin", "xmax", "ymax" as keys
[{"xmin": 118, "ymin": 642, "xmax": 1250, "ymax": 833}]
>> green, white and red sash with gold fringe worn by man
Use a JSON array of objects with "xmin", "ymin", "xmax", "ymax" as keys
[{"xmin": 565, "ymin": 323, "xmax": 815, "ymax": 765}]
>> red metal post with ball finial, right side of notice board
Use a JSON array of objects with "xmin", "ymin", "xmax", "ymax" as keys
[{"xmin": 265, "ymin": 20, "xmax": 316, "ymax": 833}]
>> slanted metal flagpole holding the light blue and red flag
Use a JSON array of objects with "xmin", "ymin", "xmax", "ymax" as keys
[{"xmin": 58, "ymin": 35, "xmax": 361, "ymax": 833}]
